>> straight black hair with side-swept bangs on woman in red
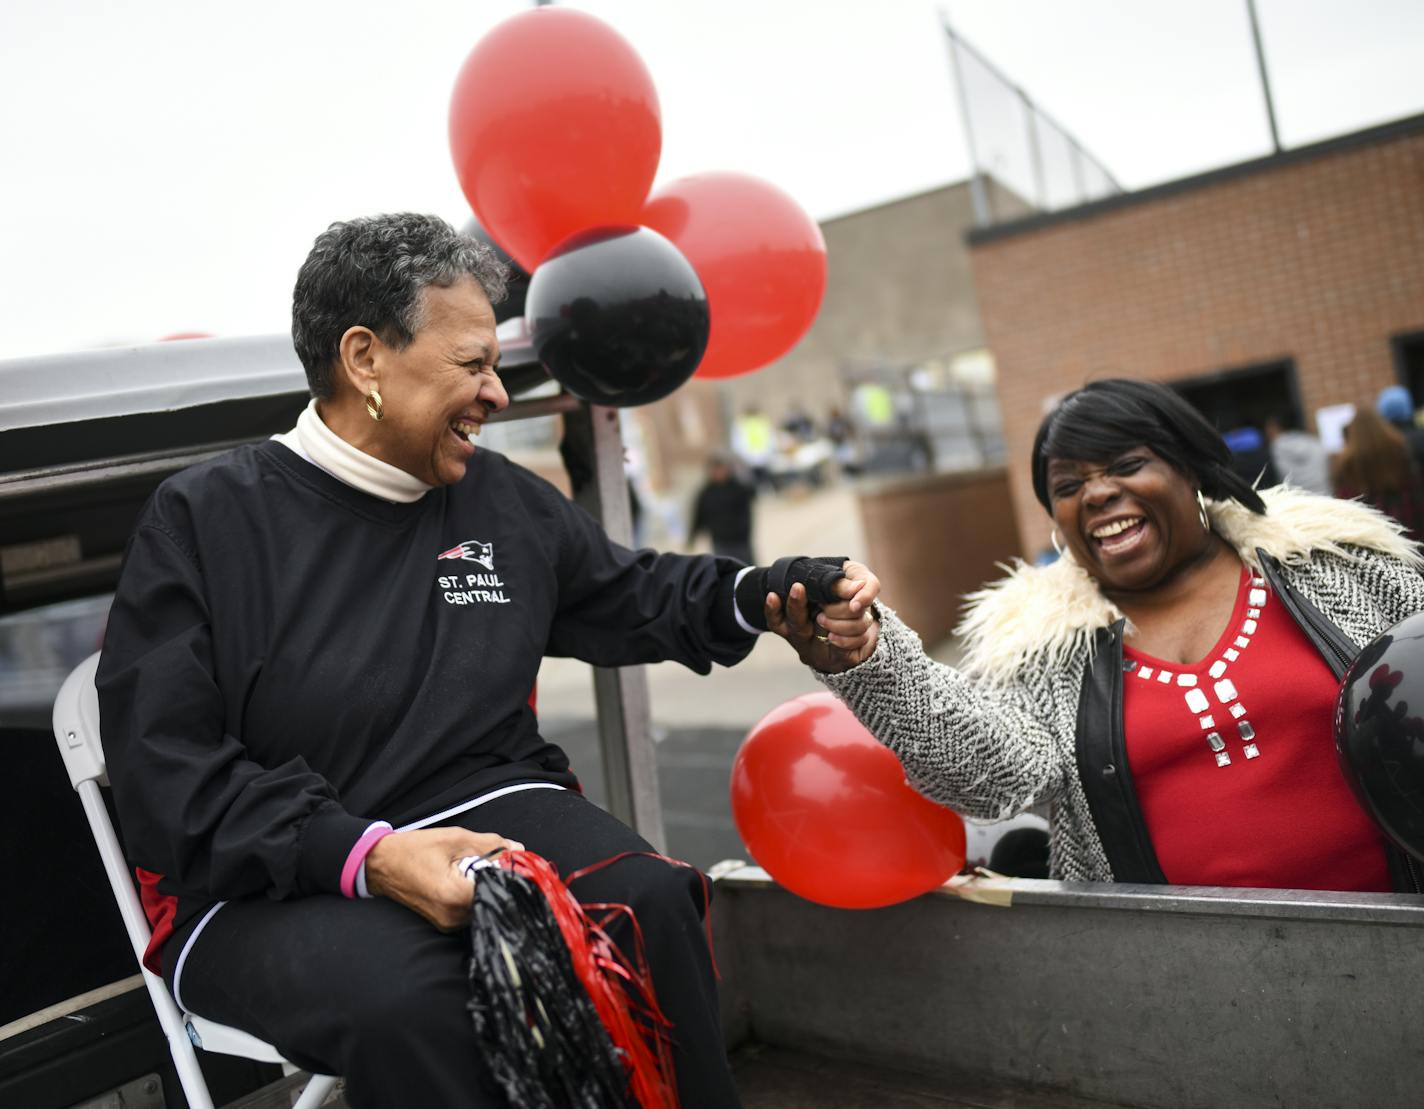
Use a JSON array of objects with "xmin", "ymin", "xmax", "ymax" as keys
[{"xmin": 1032, "ymin": 377, "xmax": 1266, "ymax": 514}]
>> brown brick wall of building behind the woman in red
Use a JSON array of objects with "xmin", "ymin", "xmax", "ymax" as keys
[{"xmin": 971, "ymin": 117, "xmax": 1424, "ymax": 551}]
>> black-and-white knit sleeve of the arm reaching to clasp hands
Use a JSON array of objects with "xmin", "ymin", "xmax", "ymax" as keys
[{"xmin": 816, "ymin": 606, "xmax": 1062, "ymax": 820}]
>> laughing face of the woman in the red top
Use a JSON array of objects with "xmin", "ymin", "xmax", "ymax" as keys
[{"xmin": 1048, "ymin": 447, "xmax": 1212, "ymax": 592}]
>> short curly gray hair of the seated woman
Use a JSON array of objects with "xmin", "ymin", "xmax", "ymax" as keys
[{"xmin": 292, "ymin": 212, "xmax": 508, "ymax": 399}]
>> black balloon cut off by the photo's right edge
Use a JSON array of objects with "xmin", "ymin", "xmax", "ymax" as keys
[{"xmin": 1334, "ymin": 612, "xmax": 1424, "ymax": 858}]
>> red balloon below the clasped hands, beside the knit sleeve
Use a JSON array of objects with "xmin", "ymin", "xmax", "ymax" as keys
[{"xmin": 732, "ymin": 693, "xmax": 964, "ymax": 908}]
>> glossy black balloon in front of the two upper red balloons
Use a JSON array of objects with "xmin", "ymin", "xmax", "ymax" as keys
[{"xmin": 525, "ymin": 228, "xmax": 711, "ymax": 407}]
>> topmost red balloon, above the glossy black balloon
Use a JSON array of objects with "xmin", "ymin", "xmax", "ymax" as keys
[{"xmin": 450, "ymin": 7, "xmax": 662, "ymax": 273}]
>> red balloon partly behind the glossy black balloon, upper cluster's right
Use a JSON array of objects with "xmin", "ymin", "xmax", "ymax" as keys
[{"xmin": 642, "ymin": 174, "xmax": 826, "ymax": 377}]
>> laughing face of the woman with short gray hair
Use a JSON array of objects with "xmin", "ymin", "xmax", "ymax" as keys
[{"xmin": 357, "ymin": 278, "xmax": 510, "ymax": 485}]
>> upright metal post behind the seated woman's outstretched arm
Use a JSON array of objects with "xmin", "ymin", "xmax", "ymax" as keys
[{"xmin": 590, "ymin": 404, "xmax": 666, "ymax": 851}]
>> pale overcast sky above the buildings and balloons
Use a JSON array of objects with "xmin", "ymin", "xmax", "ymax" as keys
[{"xmin": 0, "ymin": 0, "xmax": 1424, "ymax": 357}]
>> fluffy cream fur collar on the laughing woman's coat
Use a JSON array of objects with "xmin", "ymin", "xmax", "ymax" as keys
[{"xmin": 956, "ymin": 485, "xmax": 1424, "ymax": 680}]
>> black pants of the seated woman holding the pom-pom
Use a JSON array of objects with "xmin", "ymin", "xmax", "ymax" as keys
[{"xmin": 165, "ymin": 789, "xmax": 739, "ymax": 1109}]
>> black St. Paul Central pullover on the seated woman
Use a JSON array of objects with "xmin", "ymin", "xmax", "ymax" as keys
[{"xmin": 97, "ymin": 441, "xmax": 753, "ymax": 924}]
